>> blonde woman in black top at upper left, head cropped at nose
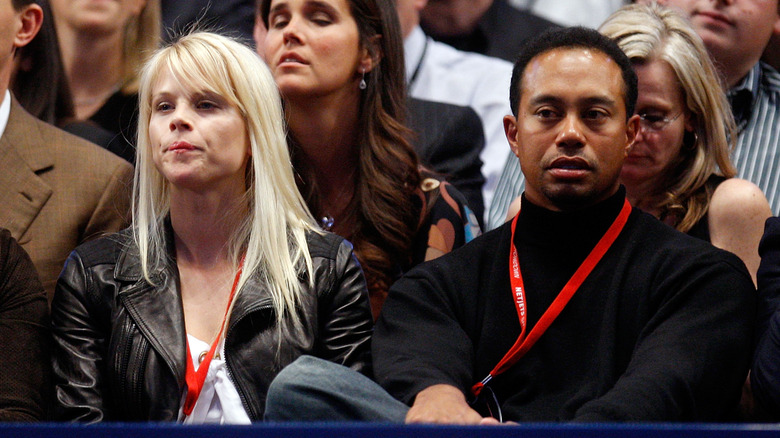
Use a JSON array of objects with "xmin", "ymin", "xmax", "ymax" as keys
[{"xmin": 50, "ymin": 0, "xmax": 161, "ymax": 161}]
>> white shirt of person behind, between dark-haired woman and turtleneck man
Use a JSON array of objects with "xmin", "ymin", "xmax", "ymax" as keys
[{"xmin": 404, "ymin": 26, "xmax": 512, "ymax": 221}]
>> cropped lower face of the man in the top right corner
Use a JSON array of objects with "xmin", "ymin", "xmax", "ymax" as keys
[{"xmin": 643, "ymin": 0, "xmax": 780, "ymax": 86}]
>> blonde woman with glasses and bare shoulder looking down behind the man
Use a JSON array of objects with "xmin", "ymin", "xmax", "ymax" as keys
[{"xmin": 599, "ymin": 4, "xmax": 772, "ymax": 283}]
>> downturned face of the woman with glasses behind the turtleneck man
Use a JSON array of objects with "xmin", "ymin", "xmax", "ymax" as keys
[{"xmin": 620, "ymin": 60, "xmax": 691, "ymax": 189}]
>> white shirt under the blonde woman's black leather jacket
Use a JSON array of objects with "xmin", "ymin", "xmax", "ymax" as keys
[{"xmin": 179, "ymin": 334, "xmax": 252, "ymax": 424}]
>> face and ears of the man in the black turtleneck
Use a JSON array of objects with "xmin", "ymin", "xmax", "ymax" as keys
[{"xmin": 504, "ymin": 48, "xmax": 638, "ymax": 211}]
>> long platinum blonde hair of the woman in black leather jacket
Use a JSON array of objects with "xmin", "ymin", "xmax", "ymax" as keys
[{"xmin": 132, "ymin": 32, "xmax": 316, "ymax": 327}]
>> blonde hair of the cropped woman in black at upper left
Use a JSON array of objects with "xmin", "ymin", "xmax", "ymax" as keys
[{"xmin": 121, "ymin": 0, "xmax": 162, "ymax": 94}]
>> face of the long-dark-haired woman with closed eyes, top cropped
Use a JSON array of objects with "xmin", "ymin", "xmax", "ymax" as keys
[{"xmin": 264, "ymin": 0, "xmax": 370, "ymax": 99}]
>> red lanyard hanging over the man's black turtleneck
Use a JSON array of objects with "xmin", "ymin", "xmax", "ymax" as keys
[{"xmin": 471, "ymin": 199, "xmax": 631, "ymax": 396}]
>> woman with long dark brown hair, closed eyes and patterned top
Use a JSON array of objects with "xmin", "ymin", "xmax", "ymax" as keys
[{"xmin": 260, "ymin": 0, "xmax": 479, "ymax": 318}]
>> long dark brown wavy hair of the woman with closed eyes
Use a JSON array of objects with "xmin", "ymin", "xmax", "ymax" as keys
[{"xmin": 259, "ymin": 0, "xmax": 422, "ymax": 316}]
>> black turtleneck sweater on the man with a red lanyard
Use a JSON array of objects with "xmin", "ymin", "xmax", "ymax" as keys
[{"xmin": 373, "ymin": 188, "xmax": 755, "ymax": 421}]
